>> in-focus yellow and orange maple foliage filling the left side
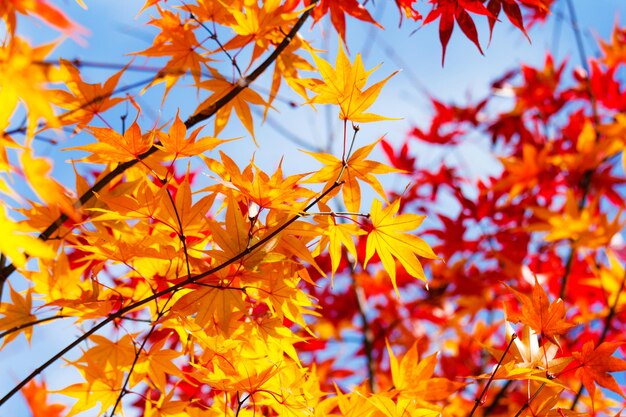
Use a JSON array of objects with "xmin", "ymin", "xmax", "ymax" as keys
[{"xmin": 0, "ymin": 0, "xmax": 446, "ymax": 417}]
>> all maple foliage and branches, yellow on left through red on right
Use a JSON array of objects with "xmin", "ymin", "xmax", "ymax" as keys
[{"xmin": 0, "ymin": 0, "xmax": 626, "ymax": 416}]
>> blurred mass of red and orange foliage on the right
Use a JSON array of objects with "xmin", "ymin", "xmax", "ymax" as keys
[{"xmin": 296, "ymin": 20, "xmax": 626, "ymax": 416}]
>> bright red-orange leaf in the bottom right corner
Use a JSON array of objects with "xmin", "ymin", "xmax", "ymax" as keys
[{"xmin": 572, "ymin": 340, "xmax": 626, "ymax": 404}]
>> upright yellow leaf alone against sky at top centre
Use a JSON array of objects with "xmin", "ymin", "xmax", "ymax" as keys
[{"xmin": 298, "ymin": 44, "xmax": 397, "ymax": 123}]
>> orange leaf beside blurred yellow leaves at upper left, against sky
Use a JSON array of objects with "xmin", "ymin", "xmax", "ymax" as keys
[{"xmin": 51, "ymin": 59, "xmax": 126, "ymax": 125}]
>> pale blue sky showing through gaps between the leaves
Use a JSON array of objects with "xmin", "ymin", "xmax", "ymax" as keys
[{"xmin": 0, "ymin": 0, "xmax": 626, "ymax": 415}]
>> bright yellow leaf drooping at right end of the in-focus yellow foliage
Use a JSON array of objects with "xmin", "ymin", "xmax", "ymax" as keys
[{"xmin": 363, "ymin": 199, "xmax": 438, "ymax": 295}]
